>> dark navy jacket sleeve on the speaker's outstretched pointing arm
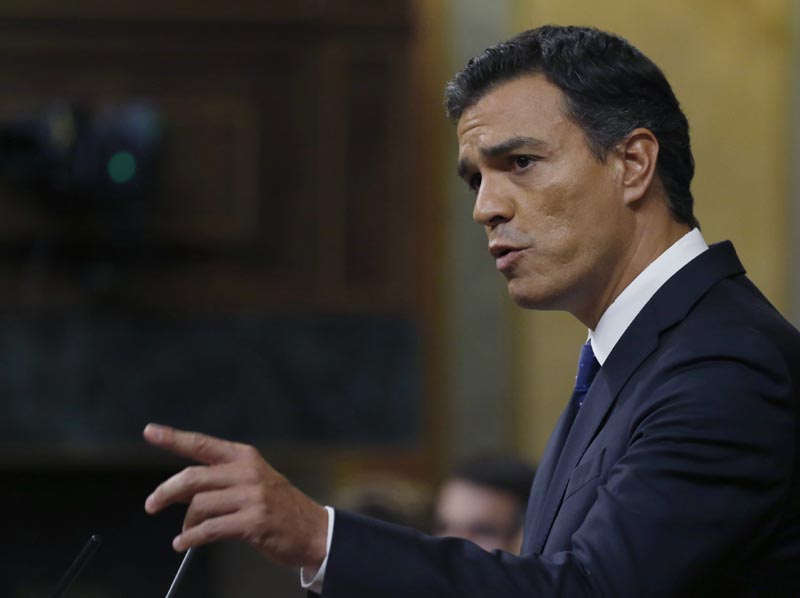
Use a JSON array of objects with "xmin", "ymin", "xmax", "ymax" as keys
[{"xmin": 323, "ymin": 331, "xmax": 796, "ymax": 598}]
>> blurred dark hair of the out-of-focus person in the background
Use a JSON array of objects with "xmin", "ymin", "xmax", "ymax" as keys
[{"xmin": 448, "ymin": 453, "xmax": 536, "ymax": 513}]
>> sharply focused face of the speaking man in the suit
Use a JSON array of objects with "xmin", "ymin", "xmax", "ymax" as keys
[{"xmin": 457, "ymin": 75, "xmax": 634, "ymax": 327}]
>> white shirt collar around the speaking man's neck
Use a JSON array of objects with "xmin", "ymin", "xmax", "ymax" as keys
[{"xmin": 589, "ymin": 228, "xmax": 708, "ymax": 365}]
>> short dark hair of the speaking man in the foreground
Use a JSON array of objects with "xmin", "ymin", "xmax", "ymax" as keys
[{"xmin": 445, "ymin": 25, "xmax": 698, "ymax": 227}]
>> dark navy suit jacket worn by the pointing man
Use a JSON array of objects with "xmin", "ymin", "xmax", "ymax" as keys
[{"xmin": 323, "ymin": 243, "xmax": 800, "ymax": 598}]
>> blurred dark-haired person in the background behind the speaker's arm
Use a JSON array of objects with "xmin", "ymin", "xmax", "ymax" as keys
[{"xmin": 433, "ymin": 454, "xmax": 534, "ymax": 554}]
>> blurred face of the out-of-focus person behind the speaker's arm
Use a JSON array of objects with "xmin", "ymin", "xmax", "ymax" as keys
[{"xmin": 433, "ymin": 479, "xmax": 523, "ymax": 554}]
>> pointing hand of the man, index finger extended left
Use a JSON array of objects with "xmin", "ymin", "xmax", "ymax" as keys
[{"xmin": 144, "ymin": 424, "xmax": 328, "ymax": 569}]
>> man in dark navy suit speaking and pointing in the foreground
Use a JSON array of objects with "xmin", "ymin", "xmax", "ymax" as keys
[{"xmin": 145, "ymin": 27, "xmax": 800, "ymax": 598}]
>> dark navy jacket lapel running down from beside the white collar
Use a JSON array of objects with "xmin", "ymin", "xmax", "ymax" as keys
[{"xmin": 523, "ymin": 242, "xmax": 744, "ymax": 554}]
